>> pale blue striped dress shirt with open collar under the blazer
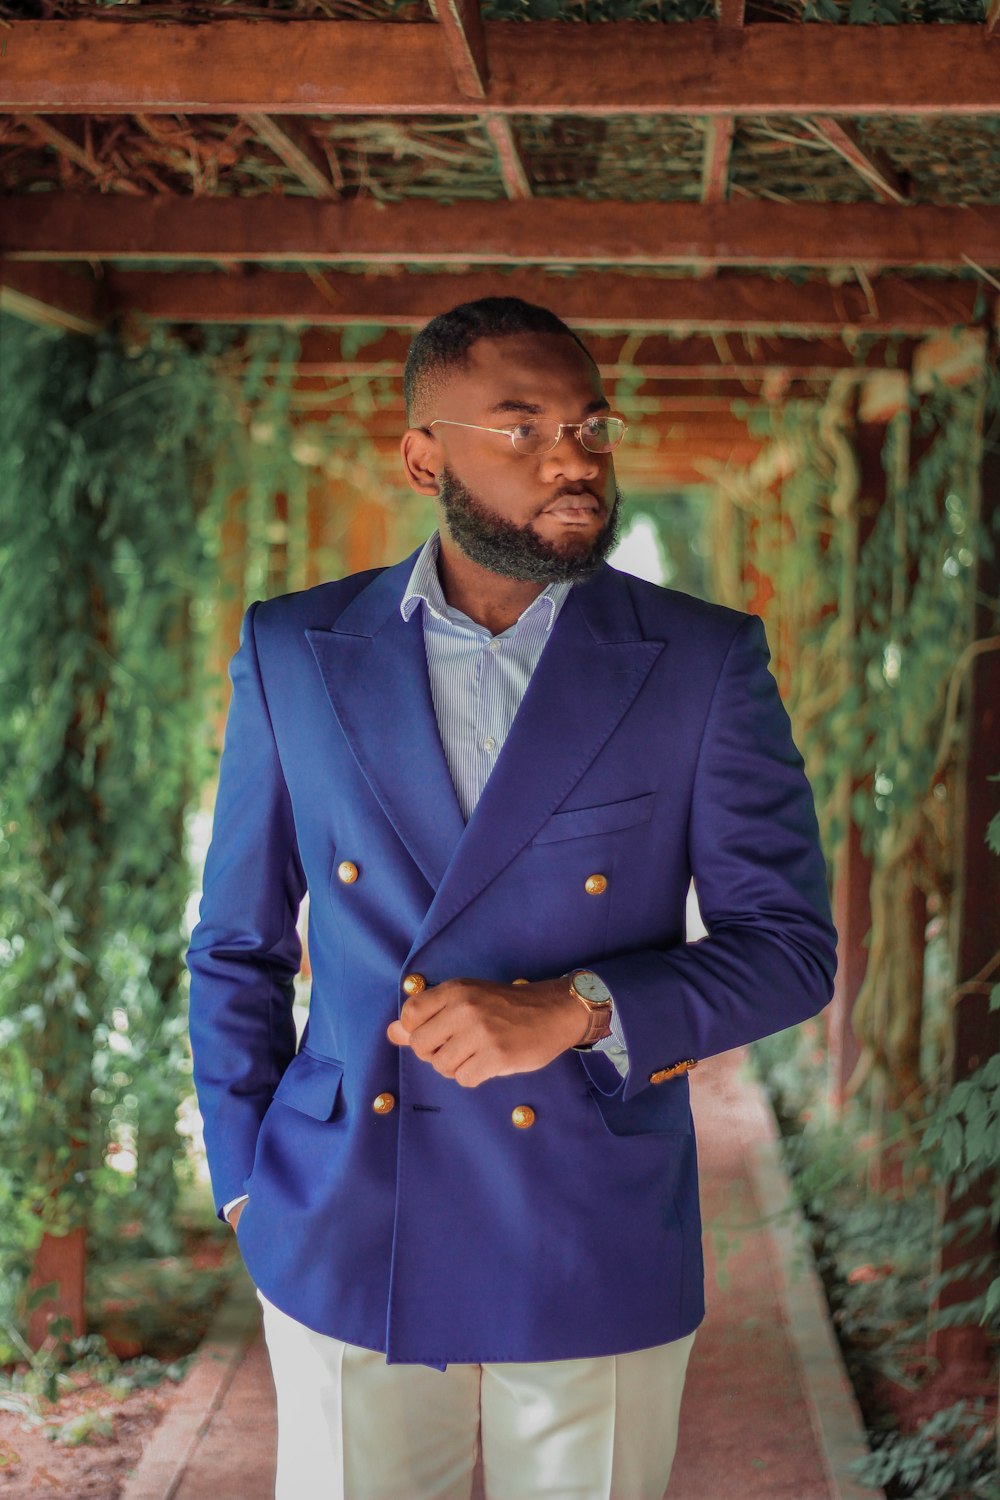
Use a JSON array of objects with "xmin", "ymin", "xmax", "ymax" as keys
[{"xmin": 399, "ymin": 531, "xmax": 628, "ymax": 1076}]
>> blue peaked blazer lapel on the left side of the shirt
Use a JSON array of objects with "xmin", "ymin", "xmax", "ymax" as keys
[{"xmin": 306, "ymin": 557, "xmax": 465, "ymax": 890}]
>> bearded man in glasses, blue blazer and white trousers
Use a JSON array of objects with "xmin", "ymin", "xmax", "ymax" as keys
[{"xmin": 189, "ymin": 299, "xmax": 835, "ymax": 1500}]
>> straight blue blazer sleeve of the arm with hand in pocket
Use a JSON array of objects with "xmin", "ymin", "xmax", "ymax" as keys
[{"xmin": 186, "ymin": 603, "xmax": 306, "ymax": 1217}]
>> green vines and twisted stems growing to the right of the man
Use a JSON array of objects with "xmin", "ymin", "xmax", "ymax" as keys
[{"xmin": 754, "ymin": 351, "xmax": 1000, "ymax": 1500}]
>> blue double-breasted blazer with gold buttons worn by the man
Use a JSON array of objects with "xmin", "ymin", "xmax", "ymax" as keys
[{"xmin": 187, "ymin": 558, "xmax": 835, "ymax": 1365}]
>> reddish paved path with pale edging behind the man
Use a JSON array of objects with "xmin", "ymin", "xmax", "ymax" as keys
[{"xmin": 134, "ymin": 1053, "xmax": 873, "ymax": 1500}]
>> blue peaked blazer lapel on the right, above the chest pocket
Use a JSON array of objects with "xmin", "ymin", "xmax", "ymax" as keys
[{"xmin": 414, "ymin": 567, "xmax": 664, "ymax": 948}]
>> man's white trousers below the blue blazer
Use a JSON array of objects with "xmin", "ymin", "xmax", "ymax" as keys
[{"xmin": 258, "ymin": 1292, "xmax": 694, "ymax": 1500}]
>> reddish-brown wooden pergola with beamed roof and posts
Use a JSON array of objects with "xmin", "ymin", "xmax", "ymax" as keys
[{"xmin": 0, "ymin": 0, "xmax": 1000, "ymax": 1380}]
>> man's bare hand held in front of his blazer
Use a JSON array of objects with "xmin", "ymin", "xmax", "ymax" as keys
[{"xmin": 387, "ymin": 980, "xmax": 588, "ymax": 1089}]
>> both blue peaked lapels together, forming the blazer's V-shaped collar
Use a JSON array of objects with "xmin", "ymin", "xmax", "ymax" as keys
[{"xmin": 306, "ymin": 554, "xmax": 663, "ymax": 947}]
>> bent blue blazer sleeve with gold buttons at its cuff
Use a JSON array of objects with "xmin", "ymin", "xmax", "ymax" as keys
[{"xmin": 594, "ymin": 615, "xmax": 837, "ymax": 1100}]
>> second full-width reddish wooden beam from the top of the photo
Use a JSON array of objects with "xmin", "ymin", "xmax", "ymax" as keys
[{"xmin": 7, "ymin": 196, "xmax": 1000, "ymax": 273}]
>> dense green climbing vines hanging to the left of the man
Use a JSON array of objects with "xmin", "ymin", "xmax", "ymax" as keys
[{"xmin": 0, "ymin": 317, "xmax": 371, "ymax": 1343}]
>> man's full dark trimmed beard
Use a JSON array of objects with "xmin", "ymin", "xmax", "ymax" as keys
[{"xmin": 439, "ymin": 468, "xmax": 622, "ymax": 584}]
